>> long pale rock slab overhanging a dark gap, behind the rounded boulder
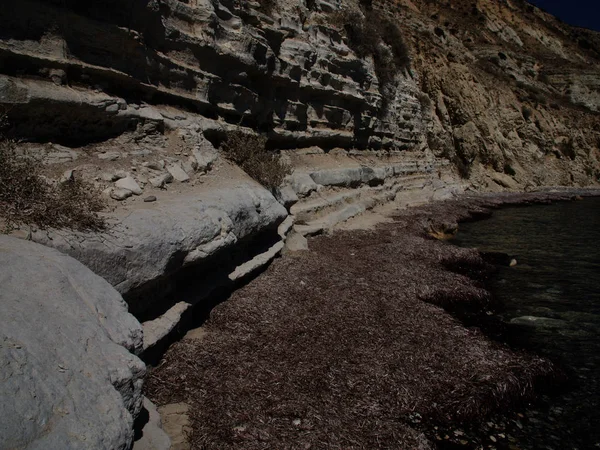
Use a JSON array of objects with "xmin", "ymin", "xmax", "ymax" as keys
[{"xmin": 32, "ymin": 183, "xmax": 287, "ymax": 307}]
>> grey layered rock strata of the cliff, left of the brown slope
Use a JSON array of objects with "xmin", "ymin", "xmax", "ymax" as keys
[{"xmin": 1, "ymin": 0, "xmax": 423, "ymax": 148}]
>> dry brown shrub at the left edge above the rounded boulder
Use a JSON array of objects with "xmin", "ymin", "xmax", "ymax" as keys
[{"xmin": 0, "ymin": 139, "xmax": 105, "ymax": 232}]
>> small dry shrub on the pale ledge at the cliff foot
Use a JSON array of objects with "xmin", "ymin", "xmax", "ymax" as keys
[{"xmin": 221, "ymin": 131, "xmax": 292, "ymax": 191}]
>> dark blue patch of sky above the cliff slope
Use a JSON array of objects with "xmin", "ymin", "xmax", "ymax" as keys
[{"xmin": 528, "ymin": 0, "xmax": 600, "ymax": 31}]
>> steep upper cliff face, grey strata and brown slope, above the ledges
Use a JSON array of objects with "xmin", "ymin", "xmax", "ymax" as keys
[{"xmin": 0, "ymin": 0, "xmax": 600, "ymax": 188}]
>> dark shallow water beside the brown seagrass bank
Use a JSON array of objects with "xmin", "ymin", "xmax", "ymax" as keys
[{"xmin": 454, "ymin": 198, "xmax": 600, "ymax": 450}]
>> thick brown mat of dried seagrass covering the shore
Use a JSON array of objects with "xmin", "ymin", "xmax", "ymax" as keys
[{"xmin": 147, "ymin": 189, "xmax": 599, "ymax": 448}]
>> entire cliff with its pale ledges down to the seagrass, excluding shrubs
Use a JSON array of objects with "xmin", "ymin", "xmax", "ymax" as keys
[{"xmin": 0, "ymin": 0, "xmax": 600, "ymax": 446}]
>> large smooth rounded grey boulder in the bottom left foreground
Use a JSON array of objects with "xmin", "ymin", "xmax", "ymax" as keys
[{"xmin": 0, "ymin": 236, "xmax": 145, "ymax": 450}]
